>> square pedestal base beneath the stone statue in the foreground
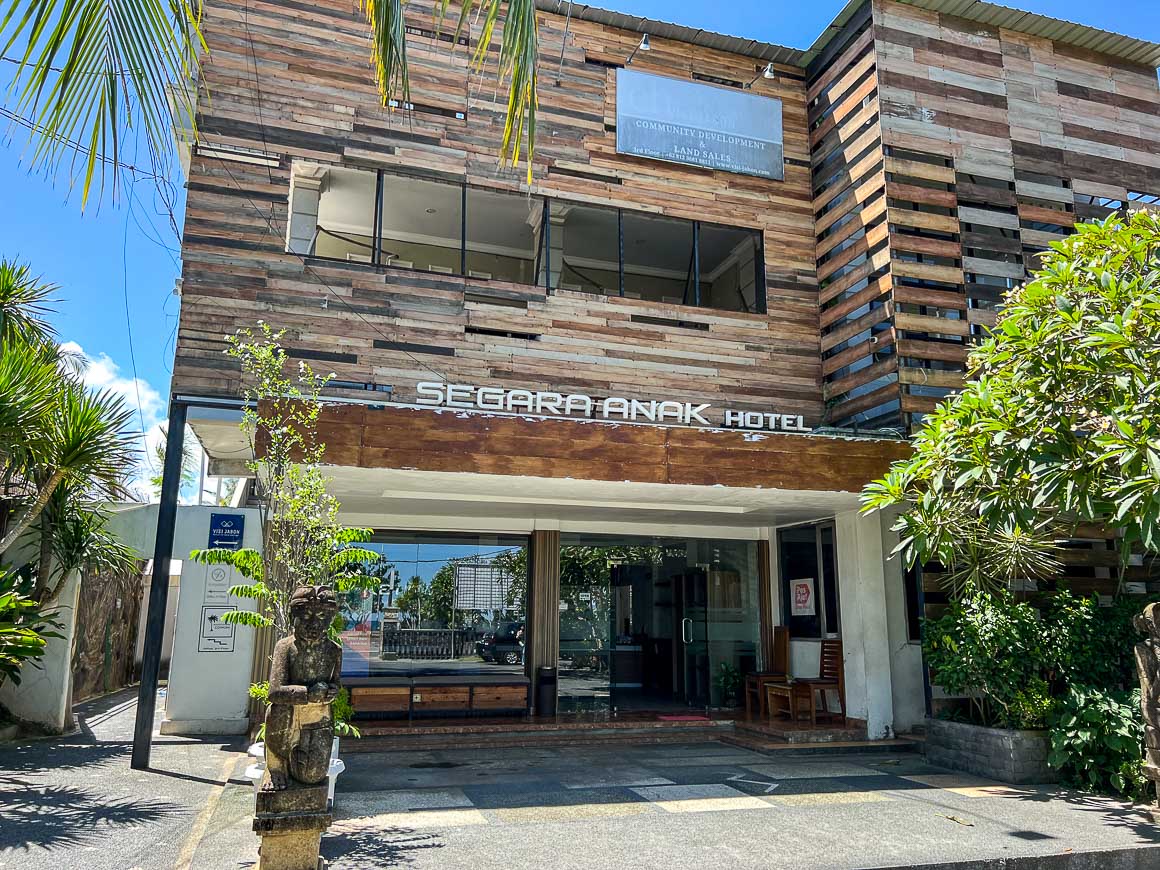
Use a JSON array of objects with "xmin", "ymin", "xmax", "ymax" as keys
[{"xmin": 254, "ymin": 775, "xmax": 334, "ymax": 870}]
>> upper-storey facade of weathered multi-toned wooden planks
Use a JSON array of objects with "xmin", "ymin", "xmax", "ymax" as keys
[{"xmin": 173, "ymin": 0, "xmax": 1160, "ymax": 450}]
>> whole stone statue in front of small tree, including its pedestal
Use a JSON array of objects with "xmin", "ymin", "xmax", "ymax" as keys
[{"xmin": 254, "ymin": 586, "xmax": 342, "ymax": 870}]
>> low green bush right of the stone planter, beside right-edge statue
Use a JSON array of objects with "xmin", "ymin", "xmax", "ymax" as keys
[{"xmin": 1047, "ymin": 687, "xmax": 1148, "ymax": 802}]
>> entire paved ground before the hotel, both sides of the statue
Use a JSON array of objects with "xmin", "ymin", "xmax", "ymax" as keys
[{"xmin": 0, "ymin": 693, "xmax": 1160, "ymax": 870}]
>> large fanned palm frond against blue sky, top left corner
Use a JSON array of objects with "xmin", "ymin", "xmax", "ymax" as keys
[{"xmin": 0, "ymin": 0, "xmax": 205, "ymax": 204}]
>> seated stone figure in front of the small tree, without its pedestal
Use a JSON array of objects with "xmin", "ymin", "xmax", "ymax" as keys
[{"xmin": 262, "ymin": 586, "xmax": 342, "ymax": 791}]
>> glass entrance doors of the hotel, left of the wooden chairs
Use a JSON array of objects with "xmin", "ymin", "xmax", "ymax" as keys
[{"xmin": 559, "ymin": 534, "xmax": 761, "ymax": 716}]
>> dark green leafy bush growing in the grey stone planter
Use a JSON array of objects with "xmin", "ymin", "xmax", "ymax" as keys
[{"xmin": 923, "ymin": 593, "xmax": 1051, "ymax": 728}]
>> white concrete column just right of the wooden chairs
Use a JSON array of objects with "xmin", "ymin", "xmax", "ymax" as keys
[{"xmin": 834, "ymin": 510, "xmax": 894, "ymax": 740}]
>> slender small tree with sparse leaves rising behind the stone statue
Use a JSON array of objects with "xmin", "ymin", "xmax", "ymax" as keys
[{"xmin": 190, "ymin": 321, "xmax": 379, "ymax": 637}]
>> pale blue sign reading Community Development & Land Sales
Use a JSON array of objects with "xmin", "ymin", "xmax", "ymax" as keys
[{"xmin": 616, "ymin": 68, "xmax": 785, "ymax": 181}]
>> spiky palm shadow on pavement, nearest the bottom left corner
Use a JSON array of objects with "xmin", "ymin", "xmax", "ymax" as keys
[{"xmin": 0, "ymin": 780, "xmax": 184, "ymax": 849}]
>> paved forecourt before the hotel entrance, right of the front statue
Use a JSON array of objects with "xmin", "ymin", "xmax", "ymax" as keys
[{"xmin": 324, "ymin": 742, "xmax": 1160, "ymax": 870}]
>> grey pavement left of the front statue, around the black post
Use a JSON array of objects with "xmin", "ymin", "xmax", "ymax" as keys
[{"xmin": 0, "ymin": 689, "xmax": 258, "ymax": 870}]
